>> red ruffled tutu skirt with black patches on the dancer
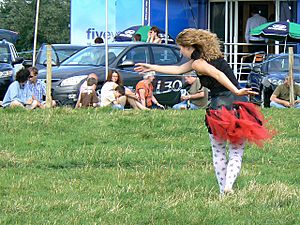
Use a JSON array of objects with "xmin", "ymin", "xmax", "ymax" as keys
[{"xmin": 206, "ymin": 102, "xmax": 275, "ymax": 147}]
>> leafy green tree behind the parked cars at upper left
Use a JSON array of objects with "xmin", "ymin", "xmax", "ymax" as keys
[{"xmin": 0, "ymin": 0, "xmax": 71, "ymax": 56}]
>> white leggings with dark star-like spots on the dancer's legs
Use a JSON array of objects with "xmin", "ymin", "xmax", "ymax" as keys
[{"xmin": 209, "ymin": 134, "xmax": 245, "ymax": 193}]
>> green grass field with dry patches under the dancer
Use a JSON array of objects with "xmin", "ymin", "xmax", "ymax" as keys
[{"xmin": 0, "ymin": 108, "xmax": 300, "ymax": 224}]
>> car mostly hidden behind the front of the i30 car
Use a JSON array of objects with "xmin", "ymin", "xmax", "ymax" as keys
[{"xmin": 23, "ymin": 44, "xmax": 86, "ymax": 70}]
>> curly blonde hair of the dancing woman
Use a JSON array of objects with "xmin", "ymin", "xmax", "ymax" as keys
[{"xmin": 176, "ymin": 28, "xmax": 223, "ymax": 61}]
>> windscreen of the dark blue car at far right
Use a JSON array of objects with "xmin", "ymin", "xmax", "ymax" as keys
[{"xmin": 268, "ymin": 56, "xmax": 300, "ymax": 73}]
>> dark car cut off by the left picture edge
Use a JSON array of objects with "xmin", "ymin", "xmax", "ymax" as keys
[{"xmin": 0, "ymin": 40, "xmax": 23, "ymax": 100}]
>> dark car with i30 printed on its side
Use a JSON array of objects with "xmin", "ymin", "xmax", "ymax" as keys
[{"xmin": 40, "ymin": 42, "xmax": 186, "ymax": 106}]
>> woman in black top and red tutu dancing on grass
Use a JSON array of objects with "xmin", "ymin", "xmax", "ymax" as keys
[{"xmin": 135, "ymin": 28, "xmax": 272, "ymax": 194}]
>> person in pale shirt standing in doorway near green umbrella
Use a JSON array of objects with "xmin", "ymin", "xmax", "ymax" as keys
[{"xmin": 245, "ymin": 7, "xmax": 267, "ymax": 52}]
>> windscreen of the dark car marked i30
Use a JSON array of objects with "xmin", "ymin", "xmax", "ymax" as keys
[{"xmin": 61, "ymin": 46, "xmax": 126, "ymax": 66}]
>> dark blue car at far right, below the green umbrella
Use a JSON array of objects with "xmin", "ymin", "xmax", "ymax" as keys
[{"xmin": 247, "ymin": 54, "xmax": 300, "ymax": 107}]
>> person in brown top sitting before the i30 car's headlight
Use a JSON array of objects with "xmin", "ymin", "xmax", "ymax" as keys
[{"xmin": 78, "ymin": 77, "xmax": 99, "ymax": 108}]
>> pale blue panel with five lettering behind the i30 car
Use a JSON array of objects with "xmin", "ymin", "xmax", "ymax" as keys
[{"xmin": 70, "ymin": 0, "xmax": 142, "ymax": 45}]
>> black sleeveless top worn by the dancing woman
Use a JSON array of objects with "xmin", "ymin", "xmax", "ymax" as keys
[{"xmin": 198, "ymin": 58, "xmax": 240, "ymax": 96}]
